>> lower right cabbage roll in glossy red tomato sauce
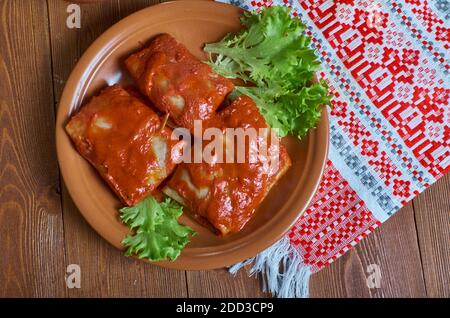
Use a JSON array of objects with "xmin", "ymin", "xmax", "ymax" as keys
[{"xmin": 163, "ymin": 96, "xmax": 291, "ymax": 235}]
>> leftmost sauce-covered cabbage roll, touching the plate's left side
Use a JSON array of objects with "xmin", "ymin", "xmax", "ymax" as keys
[{"xmin": 66, "ymin": 85, "xmax": 178, "ymax": 205}]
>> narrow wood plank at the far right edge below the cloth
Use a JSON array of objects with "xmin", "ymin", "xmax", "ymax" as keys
[{"xmin": 414, "ymin": 175, "xmax": 450, "ymax": 298}]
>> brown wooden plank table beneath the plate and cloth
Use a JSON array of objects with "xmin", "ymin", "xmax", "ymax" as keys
[{"xmin": 0, "ymin": 0, "xmax": 450, "ymax": 297}]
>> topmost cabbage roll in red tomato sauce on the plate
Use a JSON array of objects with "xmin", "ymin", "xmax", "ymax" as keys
[{"xmin": 125, "ymin": 34, "xmax": 234, "ymax": 131}]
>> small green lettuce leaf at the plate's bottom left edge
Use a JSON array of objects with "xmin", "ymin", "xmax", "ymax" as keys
[{"xmin": 120, "ymin": 197, "xmax": 196, "ymax": 261}]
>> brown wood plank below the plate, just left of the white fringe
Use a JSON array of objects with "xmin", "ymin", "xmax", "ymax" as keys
[{"xmin": 186, "ymin": 269, "xmax": 270, "ymax": 298}]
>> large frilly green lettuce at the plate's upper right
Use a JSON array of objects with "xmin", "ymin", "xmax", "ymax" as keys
[{"xmin": 204, "ymin": 6, "xmax": 331, "ymax": 138}]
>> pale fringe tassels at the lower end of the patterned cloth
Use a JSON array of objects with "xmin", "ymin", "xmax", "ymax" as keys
[{"xmin": 228, "ymin": 237, "xmax": 311, "ymax": 298}]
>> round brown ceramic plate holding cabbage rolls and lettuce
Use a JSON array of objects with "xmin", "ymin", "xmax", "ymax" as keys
[{"xmin": 56, "ymin": 1, "xmax": 329, "ymax": 270}]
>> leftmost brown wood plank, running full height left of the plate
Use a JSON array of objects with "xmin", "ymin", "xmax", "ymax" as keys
[{"xmin": 0, "ymin": 0, "xmax": 66, "ymax": 297}]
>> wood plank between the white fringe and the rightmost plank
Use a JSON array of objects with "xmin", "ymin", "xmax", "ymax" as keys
[{"xmin": 310, "ymin": 203, "xmax": 426, "ymax": 297}]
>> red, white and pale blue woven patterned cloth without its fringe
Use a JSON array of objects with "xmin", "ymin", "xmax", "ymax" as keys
[{"xmin": 225, "ymin": 0, "xmax": 450, "ymax": 272}]
